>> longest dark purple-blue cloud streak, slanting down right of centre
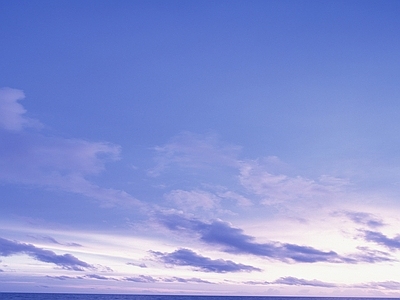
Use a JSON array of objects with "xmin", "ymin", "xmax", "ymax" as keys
[{"xmin": 159, "ymin": 214, "xmax": 344, "ymax": 263}]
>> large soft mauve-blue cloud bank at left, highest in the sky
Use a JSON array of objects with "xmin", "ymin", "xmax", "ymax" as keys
[{"xmin": 0, "ymin": 88, "xmax": 140, "ymax": 205}]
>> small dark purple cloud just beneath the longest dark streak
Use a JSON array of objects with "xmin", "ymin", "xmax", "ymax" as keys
[{"xmin": 151, "ymin": 249, "xmax": 261, "ymax": 273}]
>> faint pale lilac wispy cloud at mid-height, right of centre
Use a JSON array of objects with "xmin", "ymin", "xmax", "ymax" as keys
[{"xmin": 149, "ymin": 132, "xmax": 349, "ymax": 211}]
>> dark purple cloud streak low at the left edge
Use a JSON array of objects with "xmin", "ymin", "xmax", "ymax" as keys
[{"xmin": 0, "ymin": 238, "xmax": 94, "ymax": 271}]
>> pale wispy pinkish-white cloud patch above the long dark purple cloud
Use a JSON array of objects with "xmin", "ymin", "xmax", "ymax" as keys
[{"xmin": 149, "ymin": 133, "xmax": 350, "ymax": 212}]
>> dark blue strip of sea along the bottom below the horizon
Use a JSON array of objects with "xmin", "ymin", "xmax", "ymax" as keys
[{"xmin": 0, "ymin": 293, "xmax": 394, "ymax": 300}]
